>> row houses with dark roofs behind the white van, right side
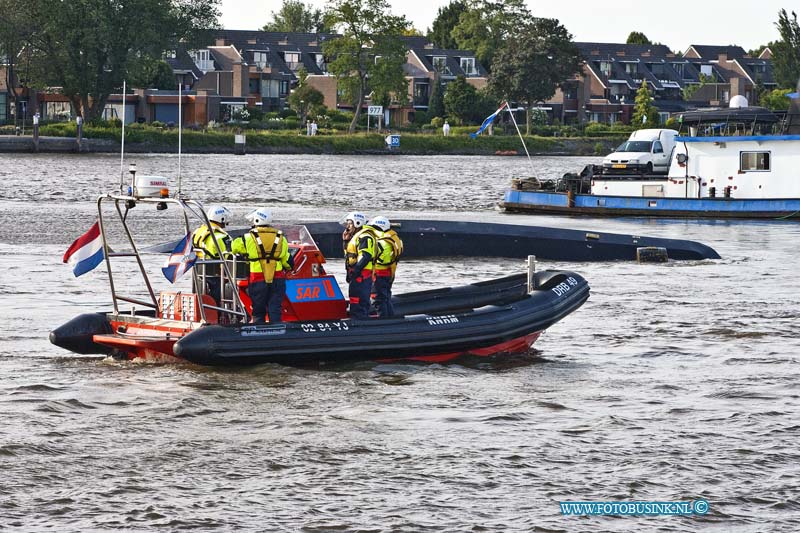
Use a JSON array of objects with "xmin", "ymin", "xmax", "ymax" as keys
[{"xmin": 548, "ymin": 43, "xmax": 776, "ymax": 123}]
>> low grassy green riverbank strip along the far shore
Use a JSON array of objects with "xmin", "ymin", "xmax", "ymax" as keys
[{"xmin": 0, "ymin": 129, "xmax": 624, "ymax": 155}]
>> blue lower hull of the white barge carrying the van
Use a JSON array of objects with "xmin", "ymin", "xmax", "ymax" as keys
[{"xmin": 501, "ymin": 190, "xmax": 800, "ymax": 219}]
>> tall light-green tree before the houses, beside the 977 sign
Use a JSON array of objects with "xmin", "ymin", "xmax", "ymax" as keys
[{"xmin": 322, "ymin": 0, "xmax": 409, "ymax": 133}]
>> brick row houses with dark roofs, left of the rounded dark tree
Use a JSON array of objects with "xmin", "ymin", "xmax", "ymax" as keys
[{"xmin": 0, "ymin": 30, "xmax": 487, "ymax": 125}]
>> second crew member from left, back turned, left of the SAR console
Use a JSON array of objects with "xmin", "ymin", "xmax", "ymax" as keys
[{"xmin": 231, "ymin": 207, "xmax": 294, "ymax": 324}]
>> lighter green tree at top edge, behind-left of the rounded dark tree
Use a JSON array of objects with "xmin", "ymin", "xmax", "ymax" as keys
[{"xmin": 451, "ymin": 0, "xmax": 531, "ymax": 70}]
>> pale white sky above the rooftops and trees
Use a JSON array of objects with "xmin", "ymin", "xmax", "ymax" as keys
[{"xmin": 221, "ymin": 0, "xmax": 788, "ymax": 52}]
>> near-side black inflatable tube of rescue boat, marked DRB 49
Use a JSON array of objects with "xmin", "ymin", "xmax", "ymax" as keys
[{"xmin": 174, "ymin": 271, "xmax": 589, "ymax": 366}]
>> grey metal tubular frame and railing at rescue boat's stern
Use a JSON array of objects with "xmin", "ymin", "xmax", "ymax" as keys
[{"xmin": 97, "ymin": 194, "xmax": 247, "ymax": 323}]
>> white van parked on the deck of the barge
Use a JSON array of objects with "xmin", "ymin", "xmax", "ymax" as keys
[{"xmin": 603, "ymin": 129, "xmax": 678, "ymax": 174}]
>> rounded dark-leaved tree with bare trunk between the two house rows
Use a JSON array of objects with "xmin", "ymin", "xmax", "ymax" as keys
[{"xmin": 489, "ymin": 18, "xmax": 583, "ymax": 134}]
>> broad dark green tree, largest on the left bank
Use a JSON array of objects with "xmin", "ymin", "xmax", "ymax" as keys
[{"xmin": 27, "ymin": 0, "xmax": 219, "ymax": 120}]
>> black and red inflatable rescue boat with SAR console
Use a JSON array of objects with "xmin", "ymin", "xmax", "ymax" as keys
[{"xmin": 50, "ymin": 175, "xmax": 589, "ymax": 366}]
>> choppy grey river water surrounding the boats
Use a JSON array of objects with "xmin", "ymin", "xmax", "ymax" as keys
[{"xmin": 0, "ymin": 155, "xmax": 800, "ymax": 532}]
